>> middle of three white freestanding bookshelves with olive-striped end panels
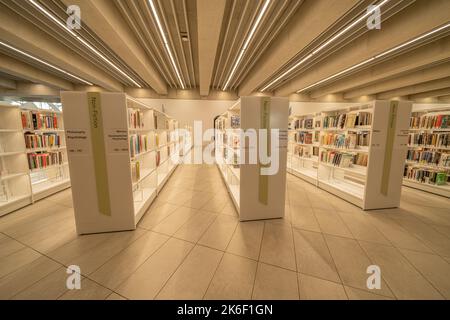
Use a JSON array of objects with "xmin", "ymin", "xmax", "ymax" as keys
[{"xmin": 215, "ymin": 97, "xmax": 289, "ymax": 221}]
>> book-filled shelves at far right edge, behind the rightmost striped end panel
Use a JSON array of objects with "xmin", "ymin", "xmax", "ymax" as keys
[{"xmin": 403, "ymin": 107, "xmax": 450, "ymax": 197}]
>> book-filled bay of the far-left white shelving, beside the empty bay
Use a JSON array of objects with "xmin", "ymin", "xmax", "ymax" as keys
[{"xmin": 20, "ymin": 109, "xmax": 70, "ymax": 201}]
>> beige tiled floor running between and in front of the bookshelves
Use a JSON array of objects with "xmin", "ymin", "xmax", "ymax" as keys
[{"xmin": 0, "ymin": 165, "xmax": 450, "ymax": 300}]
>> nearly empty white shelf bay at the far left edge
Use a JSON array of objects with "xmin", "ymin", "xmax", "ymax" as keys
[{"xmin": 0, "ymin": 103, "xmax": 33, "ymax": 216}]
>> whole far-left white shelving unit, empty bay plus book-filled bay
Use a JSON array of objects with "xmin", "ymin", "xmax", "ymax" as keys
[{"xmin": 0, "ymin": 103, "xmax": 70, "ymax": 215}]
